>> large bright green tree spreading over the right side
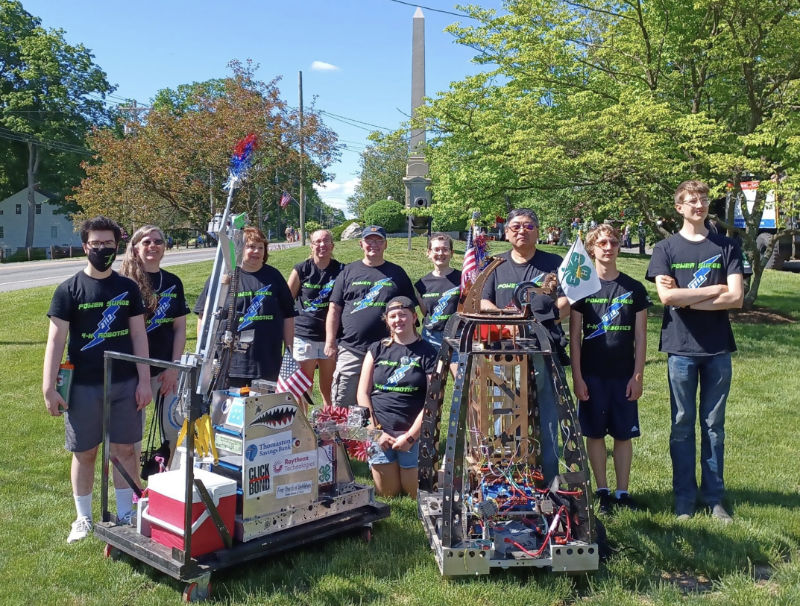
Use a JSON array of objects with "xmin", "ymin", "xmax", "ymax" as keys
[{"xmin": 425, "ymin": 0, "xmax": 800, "ymax": 305}]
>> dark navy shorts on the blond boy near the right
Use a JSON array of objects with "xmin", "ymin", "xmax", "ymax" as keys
[{"xmin": 578, "ymin": 377, "xmax": 641, "ymax": 440}]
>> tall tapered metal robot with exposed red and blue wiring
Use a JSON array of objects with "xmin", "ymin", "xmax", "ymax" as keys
[{"xmin": 418, "ymin": 260, "xmax": 600, "ymax": 577}]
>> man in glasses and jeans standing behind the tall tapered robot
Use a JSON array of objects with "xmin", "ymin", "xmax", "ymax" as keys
[{"xmin": 481, "ymin": 208, "xmax": 569, "ymax": 481}]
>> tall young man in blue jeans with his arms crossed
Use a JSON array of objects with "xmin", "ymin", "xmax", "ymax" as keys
[{"xmin": 647, "ymin": 181, "xmax": 744, "ymax": 523}]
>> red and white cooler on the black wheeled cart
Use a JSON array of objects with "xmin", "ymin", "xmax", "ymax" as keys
[{"xmin": 142, "ymin": 469, "xmax": 236, "ymax": 557}]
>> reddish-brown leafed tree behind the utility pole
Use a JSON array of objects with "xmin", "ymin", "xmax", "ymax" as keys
[{"xmin": 74, "ymin": 61, "xmax": 339, "ymax": 238}]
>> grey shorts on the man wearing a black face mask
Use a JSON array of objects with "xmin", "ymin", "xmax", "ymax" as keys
[{"xmin": 64, "ymin": 377, "xmax": 142, "ymax": 452}]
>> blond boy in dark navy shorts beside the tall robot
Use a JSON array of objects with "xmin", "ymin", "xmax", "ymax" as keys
[{"xmin": 569, "ymin": 224, "xmax": 652, "ymax": 513}]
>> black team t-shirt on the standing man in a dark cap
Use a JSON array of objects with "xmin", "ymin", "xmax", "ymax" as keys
[{"xmin": 330, "ymin": 261, "xmax": 416, "ymax": 353}]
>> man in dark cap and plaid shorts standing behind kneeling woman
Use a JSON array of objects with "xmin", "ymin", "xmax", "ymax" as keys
[{"xmin": 325, "ymin": 225, "xmax": 416, "ymax": 406}]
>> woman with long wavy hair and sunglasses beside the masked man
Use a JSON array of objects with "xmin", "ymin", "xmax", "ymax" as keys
[{"xmin": 120, "ymin": 225, "xmax": 189, "ymax": 452}]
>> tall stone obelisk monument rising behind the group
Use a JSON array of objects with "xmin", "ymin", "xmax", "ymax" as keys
[{"xmin": 403, "ymin": 7, "xmax": 431, "ymax": 235}]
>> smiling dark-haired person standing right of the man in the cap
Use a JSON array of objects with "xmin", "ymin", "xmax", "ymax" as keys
[{"xmin": 414, "ymin": 232, "xmax": 461, "ymax": 349}]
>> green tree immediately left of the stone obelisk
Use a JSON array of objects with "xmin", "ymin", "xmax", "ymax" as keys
[{"xmin": 347, "ymin": 130, "xmax": 408, "ymax": 217}]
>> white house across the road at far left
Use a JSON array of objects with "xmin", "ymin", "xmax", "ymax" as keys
[{"xmin": 0, "ymin": 189, "xmax": 81, "ymax": 255}]
